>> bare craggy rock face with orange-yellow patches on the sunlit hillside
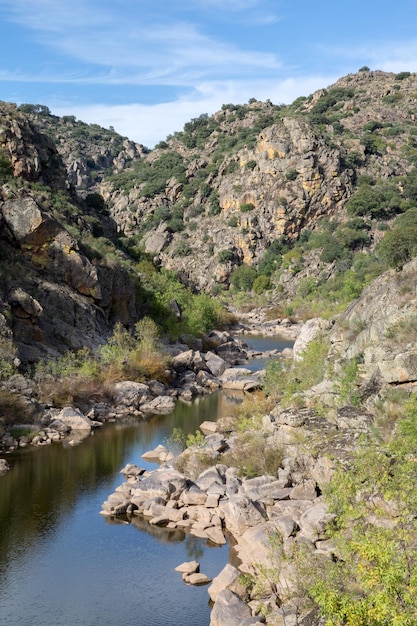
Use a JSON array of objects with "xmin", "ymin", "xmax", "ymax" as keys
[{"xmin": 102, "ymin": 112, "xmax": 352, "ymax": 289}]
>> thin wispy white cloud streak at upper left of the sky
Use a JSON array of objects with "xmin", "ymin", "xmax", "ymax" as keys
[{"xmin": 0, "ymin": 0, "xmax": 281, "ymax": 85}]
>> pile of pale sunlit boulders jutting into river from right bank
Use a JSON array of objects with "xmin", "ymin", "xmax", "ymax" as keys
[{"xmin": 101, "ymin": 408, "xmax": 371, "ymax": 626}]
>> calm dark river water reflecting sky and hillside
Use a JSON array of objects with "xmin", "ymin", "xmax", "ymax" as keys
[{"xmin": 0, "ymin": 337, "xmax": 292, "ymax": 626}]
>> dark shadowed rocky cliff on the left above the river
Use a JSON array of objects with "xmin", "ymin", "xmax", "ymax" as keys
[{"xmin": 0, "ymin": 105, "xmax": 146, "ymax": 363}]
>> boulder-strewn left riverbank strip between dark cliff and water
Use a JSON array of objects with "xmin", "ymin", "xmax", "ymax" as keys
[{"xmin": 0, "ymin": 320, "xmax": 299, "ymax": 464}]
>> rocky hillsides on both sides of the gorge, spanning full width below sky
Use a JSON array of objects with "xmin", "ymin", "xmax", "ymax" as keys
[{"xmin": 0, "ymin": 68, "xmax": 417, "ymax": 361}]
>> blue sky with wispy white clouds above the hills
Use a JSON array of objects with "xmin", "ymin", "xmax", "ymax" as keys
[{"xmin": 0, "ymin": 0, "xmax": 417, "ymax": 147}]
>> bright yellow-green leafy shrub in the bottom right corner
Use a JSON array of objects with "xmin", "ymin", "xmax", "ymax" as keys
[{"xmin": 310, "ymin": 398, "xmax": 417, "ymax": 626}]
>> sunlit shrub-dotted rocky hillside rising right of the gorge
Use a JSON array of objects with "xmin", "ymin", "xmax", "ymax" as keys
[{"xmin": 95, "ymin": 68, "xmax": 417, "ymax": 293}]
